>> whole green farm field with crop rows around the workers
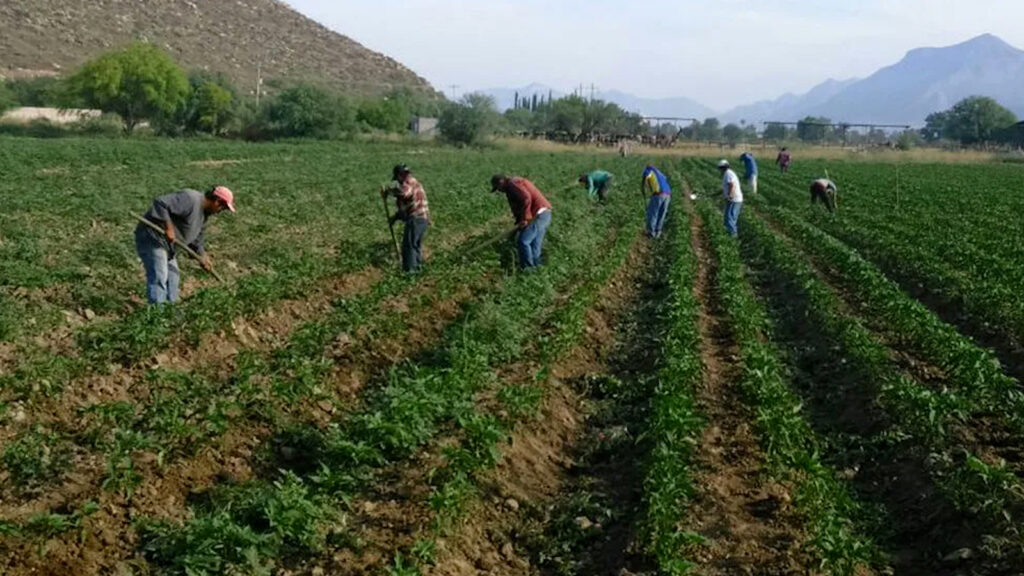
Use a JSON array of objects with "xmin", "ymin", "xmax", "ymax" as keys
[{"xmin": 0, "ymin": 138, "xmax": 1024, "ymax": 576}]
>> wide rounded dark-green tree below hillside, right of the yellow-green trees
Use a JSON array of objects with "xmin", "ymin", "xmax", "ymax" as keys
[{"xmin": 268, "ymin": 83, "xmax": 355, "ymax": 138}]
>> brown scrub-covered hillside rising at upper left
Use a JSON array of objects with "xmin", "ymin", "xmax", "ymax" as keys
[{"xmin": 0, "ymin": 0, "xmax": 433, "ymax": 94}]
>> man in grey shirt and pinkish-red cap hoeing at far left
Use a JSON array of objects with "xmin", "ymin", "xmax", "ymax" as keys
[{"xmin": 135, "ymin": 186, "xmax": 234, "ymax": 304}]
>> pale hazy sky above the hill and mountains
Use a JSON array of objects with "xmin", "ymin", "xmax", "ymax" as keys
[{"xmin": 288, "ymin": 0, "xmax": 1024, "ymax": 111}]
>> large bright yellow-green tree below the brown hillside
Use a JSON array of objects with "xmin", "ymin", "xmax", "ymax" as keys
[{"xmin": 71, "ymin": 43, "xmax": 188, "ymax": 133}]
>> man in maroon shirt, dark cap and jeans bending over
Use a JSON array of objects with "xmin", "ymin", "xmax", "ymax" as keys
[{"xmin": 490, "ymin": 174, "xmax": 551, "ymax": 270}]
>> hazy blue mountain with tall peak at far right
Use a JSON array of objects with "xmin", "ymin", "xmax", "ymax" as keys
[{"xmin": 723, "ymin": 34, "xmax": 1024, "ymax": 125}]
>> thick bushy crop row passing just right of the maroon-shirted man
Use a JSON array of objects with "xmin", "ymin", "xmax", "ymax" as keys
[{"xmin": 131, "ymin": 182, "xmax": 634, "ymax": 574}]
